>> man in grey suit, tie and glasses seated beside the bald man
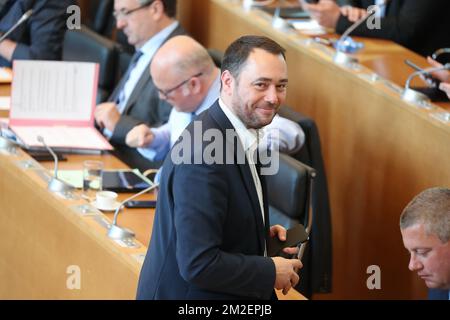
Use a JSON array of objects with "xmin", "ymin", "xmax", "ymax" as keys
[{"xmin": 95, "ymin": 0, "xmax": 185, "ymax": 169}]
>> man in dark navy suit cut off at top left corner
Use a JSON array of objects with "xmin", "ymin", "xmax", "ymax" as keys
[{"xmin": 0, "ymin": 0, "xmax": 76, "ymax": 67}]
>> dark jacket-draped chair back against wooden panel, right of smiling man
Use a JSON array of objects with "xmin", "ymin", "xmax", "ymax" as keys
[{"xmin": 279, "ymin": 106, "xmax": 332, "ymax": 297}]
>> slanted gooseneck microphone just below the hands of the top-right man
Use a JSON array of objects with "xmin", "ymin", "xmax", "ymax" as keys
[{"xmin": 333, "ymin": 5, "xmax": 380, "ymax": 65}]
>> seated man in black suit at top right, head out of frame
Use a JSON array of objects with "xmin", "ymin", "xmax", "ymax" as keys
[{"xmin": 300, "ymin": 0, "xmax": 450, "ymax": 56}]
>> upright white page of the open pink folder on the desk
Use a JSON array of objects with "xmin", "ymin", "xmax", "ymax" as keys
[{"xmin": 10, "ymin": 60, "xmax": 97, "ymax": 122}]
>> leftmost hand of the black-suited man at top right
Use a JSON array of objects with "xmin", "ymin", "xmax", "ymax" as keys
[{"xmin": 300, "ymin": 0, "xmax": 341, "ymax": 29}]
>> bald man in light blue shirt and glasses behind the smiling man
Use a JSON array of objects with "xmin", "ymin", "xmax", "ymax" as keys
[{"xmin": 126, "ymin": 36, "xmax": 304, "ymax": 161}]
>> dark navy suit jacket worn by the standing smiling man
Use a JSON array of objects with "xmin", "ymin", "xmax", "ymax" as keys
[{"xmin": 137, "ymin": 102, "xmax": 275, "ymax": 299}]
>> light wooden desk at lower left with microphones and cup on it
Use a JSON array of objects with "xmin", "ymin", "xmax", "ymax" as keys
[{"xmin": 0, "ymin": 150, "xmax": 305, "ymax": 300}]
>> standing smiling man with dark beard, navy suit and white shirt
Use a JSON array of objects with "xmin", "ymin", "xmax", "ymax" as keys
[{"xmin": 137, "ymin": 36, "xmax": 301, "ymax": 299}]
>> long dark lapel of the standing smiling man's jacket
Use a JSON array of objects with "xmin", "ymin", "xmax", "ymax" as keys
[{"xmin": 209, "ymin": 102, "xmax": 268, "ymax": 252}]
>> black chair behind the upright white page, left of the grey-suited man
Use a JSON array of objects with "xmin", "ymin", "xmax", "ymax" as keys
[{"xmin": 63, "ymin": 25, "xmax": 117, "ymax": 103}]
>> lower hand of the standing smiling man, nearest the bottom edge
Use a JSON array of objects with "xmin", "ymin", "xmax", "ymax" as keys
[{"xmin": 272, "ymin": 257, "xmax": 303, "ymax": 295}]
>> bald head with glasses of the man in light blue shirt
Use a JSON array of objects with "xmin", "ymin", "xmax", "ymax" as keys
[{"xmin": 150, "ymin": 36, "xmax": 217, "ymax": 112}]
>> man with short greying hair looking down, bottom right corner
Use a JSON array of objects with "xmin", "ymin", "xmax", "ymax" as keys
[{"xmin": 400, "ymin": 188, "xmax": 450, "ymax": 300}]
